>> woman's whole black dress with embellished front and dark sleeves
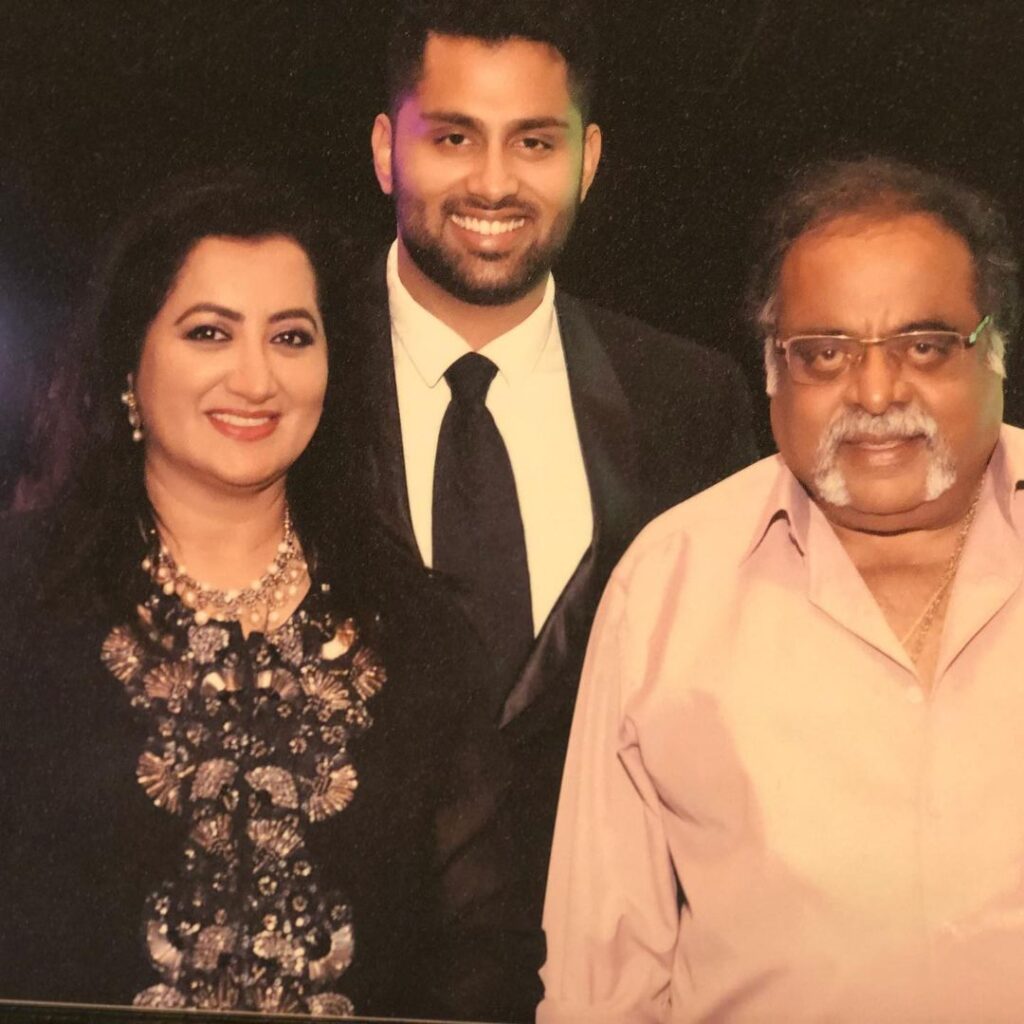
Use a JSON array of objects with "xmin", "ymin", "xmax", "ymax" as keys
[{"xmin": 0, "ymin": 517, "xmax": 520, "ymax": 1020}]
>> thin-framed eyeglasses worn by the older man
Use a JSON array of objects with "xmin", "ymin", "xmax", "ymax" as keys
[{"xmin": 775, "ymin": 315, "xmax": 992, "ymax": 384}]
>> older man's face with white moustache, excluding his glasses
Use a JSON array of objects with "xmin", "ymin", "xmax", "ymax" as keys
[{"xmin": 771, "ymin": 213, "xmax": 1002, "ymax": 534}]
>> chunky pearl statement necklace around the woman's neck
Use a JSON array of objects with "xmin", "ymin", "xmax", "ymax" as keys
[{"xmin": 142, "ymin": 508, "xmax": 309, "ymax": 627}]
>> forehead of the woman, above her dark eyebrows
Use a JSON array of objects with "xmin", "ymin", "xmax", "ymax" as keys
[{"xmin": 170, "ymin": 234, "xmax": 315, "ymax": 301}]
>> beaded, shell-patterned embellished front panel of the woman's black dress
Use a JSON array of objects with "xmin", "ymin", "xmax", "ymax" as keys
[{"xmin": 102, "ymin": 588, "xmax": 385, "ymax": 1015}]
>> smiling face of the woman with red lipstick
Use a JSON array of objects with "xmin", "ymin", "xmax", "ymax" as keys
[{"xmin": 135, "ymin": 237, "xmax": 328, "ymax": 503}]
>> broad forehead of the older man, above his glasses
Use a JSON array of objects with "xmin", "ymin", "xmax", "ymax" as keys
[{"xmin": 778, "ymin": 213, "xmax": 978, "ymax": 334}]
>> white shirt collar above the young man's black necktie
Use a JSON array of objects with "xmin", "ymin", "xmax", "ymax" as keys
[{"xmin": 387, "ymin": 241, "xmax": 555, "ymax": 387}]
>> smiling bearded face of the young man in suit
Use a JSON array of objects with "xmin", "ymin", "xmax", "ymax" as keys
[{"xmin": 372, "ymin": 29, "xmax": 601, "ymax": 335}]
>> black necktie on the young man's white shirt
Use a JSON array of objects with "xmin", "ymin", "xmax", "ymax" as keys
[{"xmin": 433, "ymin": 352, "xmax": 534, "ymax": 701}]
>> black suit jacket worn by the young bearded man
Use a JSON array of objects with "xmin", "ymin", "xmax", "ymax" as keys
[{"xmin": 342, "ymin": 261, "xmax": 757, "ymax": 1020}]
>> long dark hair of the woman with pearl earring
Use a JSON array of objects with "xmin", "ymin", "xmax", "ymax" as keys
[{"xmin": 17, "ymin": 172, "xmax": 358, "ymax": 613}]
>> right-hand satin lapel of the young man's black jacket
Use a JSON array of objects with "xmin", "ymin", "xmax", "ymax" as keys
[{"xmin": 501, "ymin": 296, "xmax": 641, "ymax": 728}]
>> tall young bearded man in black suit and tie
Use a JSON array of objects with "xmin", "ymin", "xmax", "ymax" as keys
[{"xmin": 344, "ymin": 0, "xmax": 756, "ymax": 1020}]
